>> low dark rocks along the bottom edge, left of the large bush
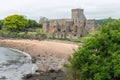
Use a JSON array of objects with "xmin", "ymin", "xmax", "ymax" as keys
[{"xmin": 23, "ymin": 70, "xmax": 66, "ymax": 80}]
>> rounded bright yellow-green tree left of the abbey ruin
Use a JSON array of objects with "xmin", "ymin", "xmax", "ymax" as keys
[{"xmin": 3, "ymin": 14, "xmax": 28, "ymax": 31}]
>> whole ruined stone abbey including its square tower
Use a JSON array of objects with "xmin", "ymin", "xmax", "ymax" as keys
[{"xmin": 43, "ymin": 9, "xmax": 97, "ymax": 38}]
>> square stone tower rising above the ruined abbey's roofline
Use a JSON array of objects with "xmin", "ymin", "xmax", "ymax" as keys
[{"xmin": 72, "ymin": 8, "xmax": 86, "ymax": 20}]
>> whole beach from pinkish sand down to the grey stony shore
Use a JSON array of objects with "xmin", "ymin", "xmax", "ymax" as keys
[{"xmin": 0, "ymin": 39, "xmax": 78, "ymax": 80}]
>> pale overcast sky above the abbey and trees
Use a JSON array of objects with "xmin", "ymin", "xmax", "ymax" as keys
[{"xmin": 0, "ymin": 0, "xmax": 120, "ymax": 20}]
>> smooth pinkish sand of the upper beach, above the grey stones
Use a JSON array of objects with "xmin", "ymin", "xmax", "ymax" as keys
[{"xmin": 0, "ymin": 39, "xmax": 78, "ymax": 58}]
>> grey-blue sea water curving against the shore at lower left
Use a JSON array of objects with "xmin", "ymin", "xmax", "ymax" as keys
[{"xmin": 0, "ymin": 47, "xmax": 33, "ymax": 80}]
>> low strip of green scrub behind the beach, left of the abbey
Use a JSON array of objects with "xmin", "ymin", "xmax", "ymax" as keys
[{"xmin": 0, "ymin": 30, "xmax": 47, "ymax": 40}]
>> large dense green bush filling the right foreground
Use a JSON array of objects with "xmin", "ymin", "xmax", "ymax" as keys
[{"xmin": 66, "ymin": 19, "xmax": 120, "ymax": 80}]
